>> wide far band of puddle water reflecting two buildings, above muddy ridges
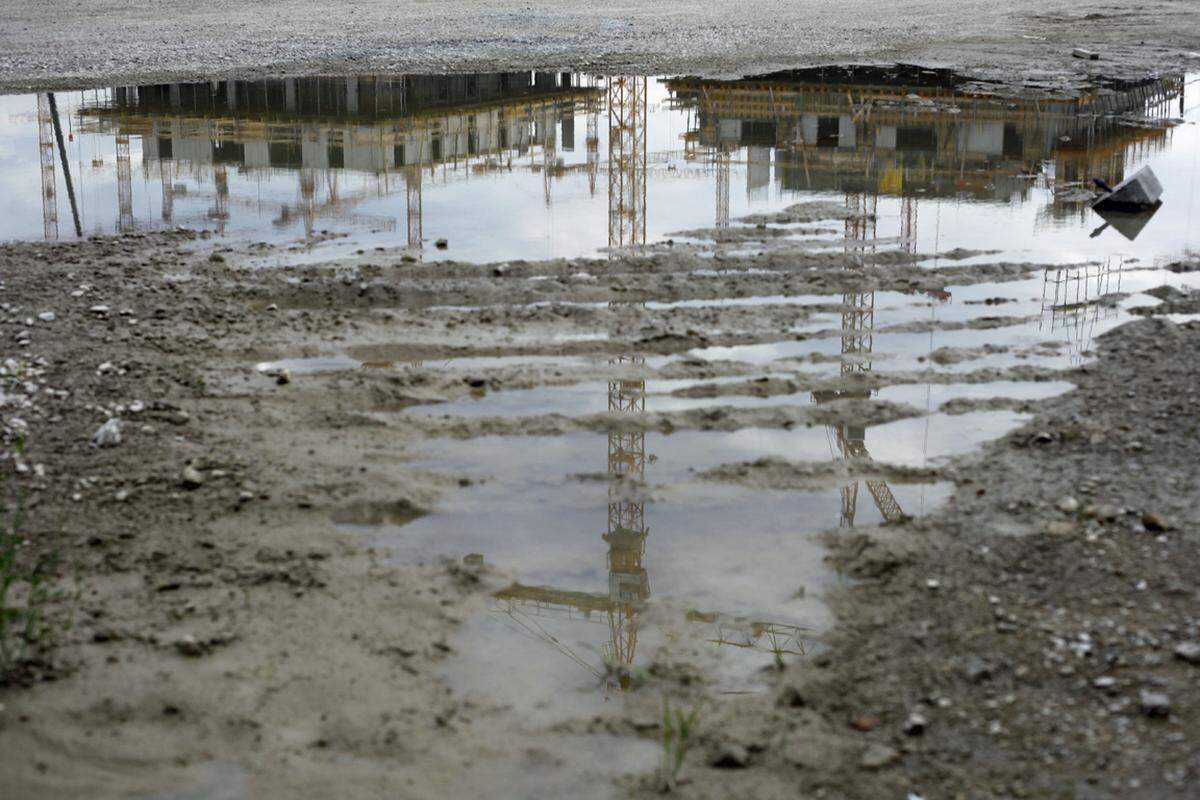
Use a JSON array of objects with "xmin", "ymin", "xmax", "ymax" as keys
[{"xmin": 0, "ymin": 67, "xmax": 1200, "ymax": 264}]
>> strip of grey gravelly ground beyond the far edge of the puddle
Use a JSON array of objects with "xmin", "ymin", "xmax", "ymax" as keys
[{"xmin": 0, "ymin": 0, "xmax": 1200, "ymax": 91}]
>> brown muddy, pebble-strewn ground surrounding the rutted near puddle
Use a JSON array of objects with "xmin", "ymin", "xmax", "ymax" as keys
[{"xmin": 0, "ymin": 194, "xmax": 1200, "ymax": 799}]
